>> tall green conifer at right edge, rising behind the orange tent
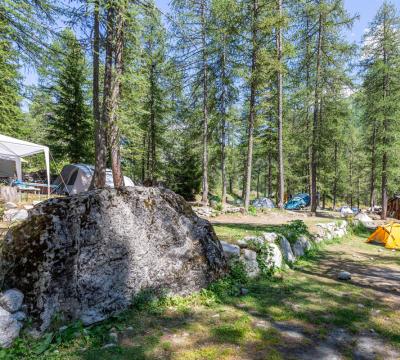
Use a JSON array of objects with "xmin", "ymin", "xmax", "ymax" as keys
[{"xmin": 363, "ymin": 1, "xmax": 400, "ymax": 219}]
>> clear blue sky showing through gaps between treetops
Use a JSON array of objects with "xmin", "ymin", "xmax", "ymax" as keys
[{"xmin": 22, "ymin": 0, "xmax": 400, "ymax": 85}]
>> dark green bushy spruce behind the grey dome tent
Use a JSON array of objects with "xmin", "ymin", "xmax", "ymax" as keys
[{"xmin": 41, "ymin": 30, "xmax": 93, "ymax": 163}]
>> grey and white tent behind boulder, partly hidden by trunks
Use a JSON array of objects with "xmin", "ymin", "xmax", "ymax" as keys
[{"xmin": 53, "ymin": 164, "xmax": 134, "ymax": 195}]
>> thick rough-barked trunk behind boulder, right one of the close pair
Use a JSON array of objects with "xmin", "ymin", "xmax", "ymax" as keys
[{"xmin": 110, "ymin": 3, "xmax": 125, "ymax": 188}]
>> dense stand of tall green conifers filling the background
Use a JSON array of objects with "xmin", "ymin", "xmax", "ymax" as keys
[{"xmin": 0, "ymin": 0, "xmax": 400, "ymax": 216}]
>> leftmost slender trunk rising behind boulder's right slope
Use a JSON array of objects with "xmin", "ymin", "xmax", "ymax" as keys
[{"xmin": 200, "ymin": 0, "xmax": 208, "ymax": 204}]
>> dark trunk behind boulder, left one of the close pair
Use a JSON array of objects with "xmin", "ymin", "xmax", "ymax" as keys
[{"xmin": 90, "ymin": 0, "xmax": 111, "ymax": 189}]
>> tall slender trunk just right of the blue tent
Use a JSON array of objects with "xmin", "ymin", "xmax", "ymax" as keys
[{"xmin": 311, "ymin": 13, "xmax": 323, "ymax": 213}]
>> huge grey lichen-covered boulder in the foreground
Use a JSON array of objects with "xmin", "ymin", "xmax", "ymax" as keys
[{"xmin": 0, "ymin": 187, "xmax": 226, "ymax": 331}]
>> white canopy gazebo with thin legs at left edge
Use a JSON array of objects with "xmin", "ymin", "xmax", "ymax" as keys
[{"xmin": 0, "ymin": 134, "xmax": 50, "ymax": 194}]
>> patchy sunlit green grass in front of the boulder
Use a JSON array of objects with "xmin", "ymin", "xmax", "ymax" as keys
[{"xmin": 0, "ymin": 224, "xmax": 400, "ymax": 360}]
